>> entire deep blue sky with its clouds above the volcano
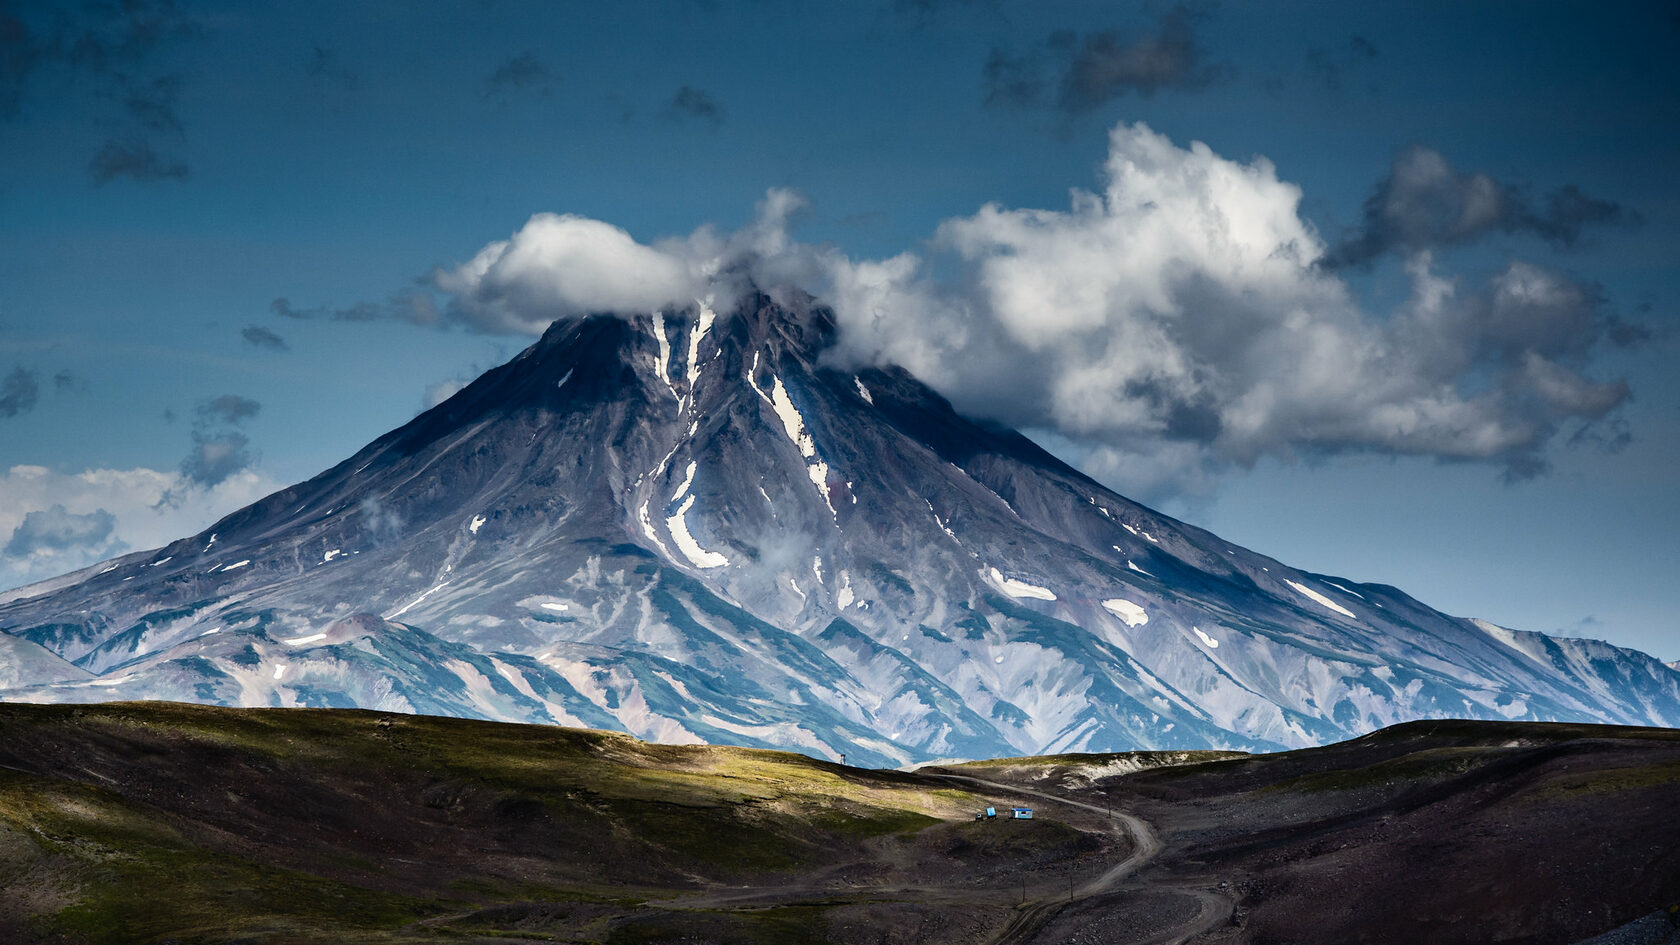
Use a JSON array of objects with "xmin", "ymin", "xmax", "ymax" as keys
[{"xmin": 0, "ymin": 0, "xmax": 1680, "ymax": 659}]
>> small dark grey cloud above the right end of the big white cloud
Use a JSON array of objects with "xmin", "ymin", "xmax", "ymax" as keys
[{"xmin": 1326, "ymin": 145, "xmax": 1640, "ymax": 266}]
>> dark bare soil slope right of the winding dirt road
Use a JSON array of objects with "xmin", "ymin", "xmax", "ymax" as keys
[{"xmin": 1107, "ymin": 723, "xmax": 1680, "ymax": 945}]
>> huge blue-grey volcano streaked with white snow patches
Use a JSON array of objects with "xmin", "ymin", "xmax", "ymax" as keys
[{"xmin": 0, "ymin": 294, "xmax": 1680, "ymax": 763}]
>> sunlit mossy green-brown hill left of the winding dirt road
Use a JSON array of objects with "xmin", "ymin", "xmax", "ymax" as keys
[{"xmin": 0, "ymin": 703, "xmax": 1112, "ymax": 942}]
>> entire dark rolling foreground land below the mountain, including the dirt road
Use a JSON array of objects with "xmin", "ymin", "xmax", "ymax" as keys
[{"xmin": 0, "ymin": 703, "xmax": 1680, "ymax": 945}]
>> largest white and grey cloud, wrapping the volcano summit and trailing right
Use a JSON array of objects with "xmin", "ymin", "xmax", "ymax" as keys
[{"xmin": 435, "ymin": 124, "xmax": 1628, "ymax": 498}]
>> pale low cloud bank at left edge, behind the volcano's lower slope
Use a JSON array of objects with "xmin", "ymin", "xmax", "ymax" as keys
[{"xmin": 0, "ymin": 466, "xmax": 281, "ymax": 590}]
